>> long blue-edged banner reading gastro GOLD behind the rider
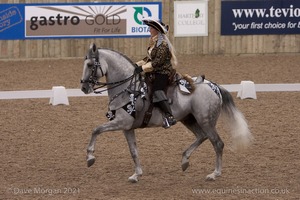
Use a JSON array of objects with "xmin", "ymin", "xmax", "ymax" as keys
[{"xmin": 0, "ymin": 2, "xmax": 162, "ymax": 40}]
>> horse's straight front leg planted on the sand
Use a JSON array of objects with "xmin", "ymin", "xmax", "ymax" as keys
[{"xmin": 124, "ymin": 129, "xmax": 143, "ymax": 183}]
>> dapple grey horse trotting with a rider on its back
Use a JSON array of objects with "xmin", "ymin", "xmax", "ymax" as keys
[{"xmin": 81, "ymin": 44, "xmax": 253, "ymax": 183}]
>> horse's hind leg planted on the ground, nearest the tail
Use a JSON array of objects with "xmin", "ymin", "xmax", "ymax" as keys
[{"xmin": 206, "ymin": 128, "xmax": 224, "ymax": 181}]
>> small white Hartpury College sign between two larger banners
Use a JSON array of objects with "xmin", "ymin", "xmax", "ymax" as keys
[{"xmin": 174, "ymin": 0, "xmax": 208, "ymax": 37}]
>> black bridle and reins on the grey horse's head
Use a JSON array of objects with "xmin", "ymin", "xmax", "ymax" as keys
[{"xmin": 80, "ymin": 57, "xmax": 134, "ymax": 94}]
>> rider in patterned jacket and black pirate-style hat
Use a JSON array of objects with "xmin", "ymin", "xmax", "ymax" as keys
[{"xmin": 135, "ymin": 18, "xmax": 177, "ymax": 128}]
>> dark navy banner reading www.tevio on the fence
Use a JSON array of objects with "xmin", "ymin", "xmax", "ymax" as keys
[{"xmin": 221, "ymin": 0, "xmax": 300, "ymax": 35}]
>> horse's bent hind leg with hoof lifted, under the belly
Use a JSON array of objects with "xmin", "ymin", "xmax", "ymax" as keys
[{"xmin": 181, "ymin": 116, "xmax": 207, "ymax": 171}]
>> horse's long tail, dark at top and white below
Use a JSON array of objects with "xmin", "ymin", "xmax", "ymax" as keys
[{"xmin": 219, "ymin": 87, "xmax": 253, "ymax": 150}]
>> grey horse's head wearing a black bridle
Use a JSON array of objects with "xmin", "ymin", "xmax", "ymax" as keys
[{"xmin": 80, "ymin": 43, "xmax": 106, "ymax": 94}]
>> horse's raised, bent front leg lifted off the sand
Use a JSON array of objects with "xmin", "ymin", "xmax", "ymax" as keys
[{"xmin": 87, "ymin": 110, "xmax": 132, "ymax": 167}]
